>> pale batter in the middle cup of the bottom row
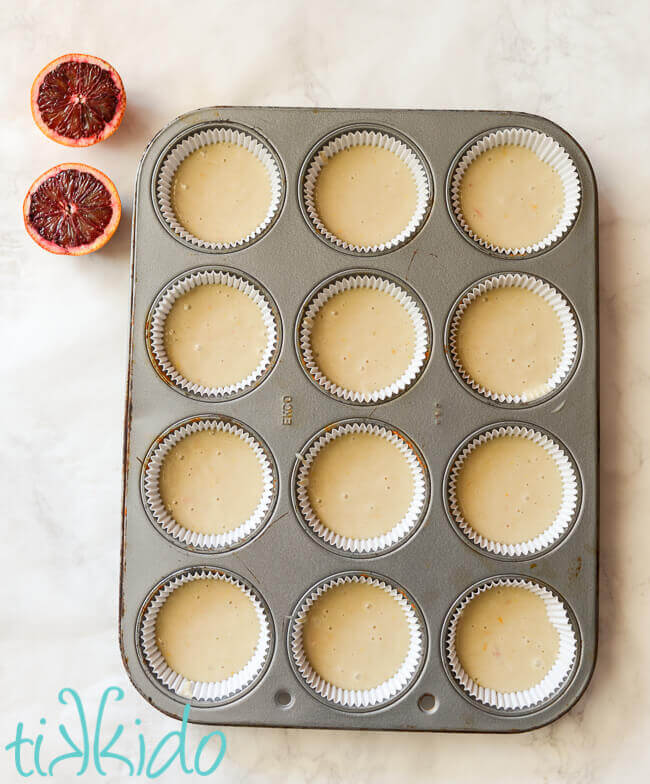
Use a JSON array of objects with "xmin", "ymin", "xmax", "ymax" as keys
[{"xmin": 303, "ymin": 583, "xmax": 410, "ymax": 689}]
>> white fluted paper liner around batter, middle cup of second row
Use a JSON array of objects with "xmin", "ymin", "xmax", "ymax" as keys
[{"xmin": 299, "ymin": 275, "xmax": 430, "ymax": 403}]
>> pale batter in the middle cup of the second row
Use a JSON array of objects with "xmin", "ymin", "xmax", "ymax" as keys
[{"xmin": 310, "ymin": 288, "xmax": 416, "ymax": 394}]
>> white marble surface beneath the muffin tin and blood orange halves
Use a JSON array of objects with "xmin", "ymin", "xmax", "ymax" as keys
[{"xmin": 0, "ymin": 0, "xmax": 650, "ymax": 784}]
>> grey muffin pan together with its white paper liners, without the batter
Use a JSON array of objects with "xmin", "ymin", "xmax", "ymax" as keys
[{"xmin": 120, "ymin": 107, "xmax": 598, "ymax": 732}]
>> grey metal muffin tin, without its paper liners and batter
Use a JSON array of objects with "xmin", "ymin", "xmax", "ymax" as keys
[{"xmin": 120, "ymin": 107, "xmax": 598, "ymax": 732}]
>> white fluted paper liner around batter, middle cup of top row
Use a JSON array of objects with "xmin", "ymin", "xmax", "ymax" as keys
[{"xmin": 302, "ymin": 130, "xmax": 431, "ymax": 254}]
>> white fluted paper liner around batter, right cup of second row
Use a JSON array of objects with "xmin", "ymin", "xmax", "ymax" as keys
[{"xmin": 448, "ymin": 273, "xmax": 578, "ymax": 404}]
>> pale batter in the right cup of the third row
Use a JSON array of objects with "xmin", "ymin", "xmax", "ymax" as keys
[{"xmin": 456, "ymin": 436, "xmax": 562, "ymax": 544}]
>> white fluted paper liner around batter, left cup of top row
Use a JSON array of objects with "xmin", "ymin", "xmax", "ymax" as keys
[{"xmin": 156, "ymin": 127, "xmax": 282, "ymax": 250}]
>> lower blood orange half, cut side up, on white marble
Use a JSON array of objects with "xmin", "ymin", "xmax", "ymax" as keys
[{"xmin": 23, "ymin": 163, "xmax": 122, "ymax": 256}]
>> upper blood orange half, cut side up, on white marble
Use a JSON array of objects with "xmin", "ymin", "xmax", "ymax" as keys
[{"xmin": 31, "ymin": 54, "xmax": 126, "ymax": 147}]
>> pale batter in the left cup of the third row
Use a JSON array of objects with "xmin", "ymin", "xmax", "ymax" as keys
[{"xmin": 159, "ymin": 430, "xmax": 264, "ymax": 534}]
